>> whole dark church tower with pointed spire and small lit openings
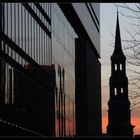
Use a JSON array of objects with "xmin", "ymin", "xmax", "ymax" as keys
[{"xmin": 107, "ymin": 12, "xmax": 134, "ymax": 136}]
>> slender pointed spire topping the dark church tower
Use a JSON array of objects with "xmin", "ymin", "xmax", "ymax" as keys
[{"xmin": 115, "ymin": 7, "xmax": 122, "ymax": 52}]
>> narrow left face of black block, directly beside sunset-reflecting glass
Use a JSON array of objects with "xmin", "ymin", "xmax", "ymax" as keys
[{"xmin": 75, "ymin": 38, "xmax": 88, "ymax": 136}]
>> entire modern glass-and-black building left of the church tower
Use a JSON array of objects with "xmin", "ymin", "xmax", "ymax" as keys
[{"xmin": 0, "ymin": 3, "xmax": 101, "ymax": 137}]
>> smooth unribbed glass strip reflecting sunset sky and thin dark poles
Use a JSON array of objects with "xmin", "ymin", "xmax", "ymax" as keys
[{"xmin": 52, "ymin": 3, "xmax": 77, "ymax": 136}]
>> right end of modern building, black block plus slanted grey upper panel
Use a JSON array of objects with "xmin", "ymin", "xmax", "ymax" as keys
[{"xmin": 58, "ymin": 3, "xmax": 102, "ymax": 136}]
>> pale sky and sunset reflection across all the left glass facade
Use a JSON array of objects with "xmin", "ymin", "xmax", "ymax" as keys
[{"xmin": 0, "ymin": 3, "xmax": 77, "ymax": 136}]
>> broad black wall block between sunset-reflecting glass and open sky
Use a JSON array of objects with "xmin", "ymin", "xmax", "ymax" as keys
[{"xmin": 75, "ymin": 37, "xmax": 101, "ymax": 136}]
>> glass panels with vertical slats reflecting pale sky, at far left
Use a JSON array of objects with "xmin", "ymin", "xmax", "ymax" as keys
[{"xmin": 2, "ymin": 3, "xmax": 52, "ymax": 104}]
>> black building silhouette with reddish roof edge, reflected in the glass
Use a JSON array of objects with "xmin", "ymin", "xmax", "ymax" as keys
[{"xmin": 14, "ymin": 65, "xmax": 55, "ymax": 136}]
